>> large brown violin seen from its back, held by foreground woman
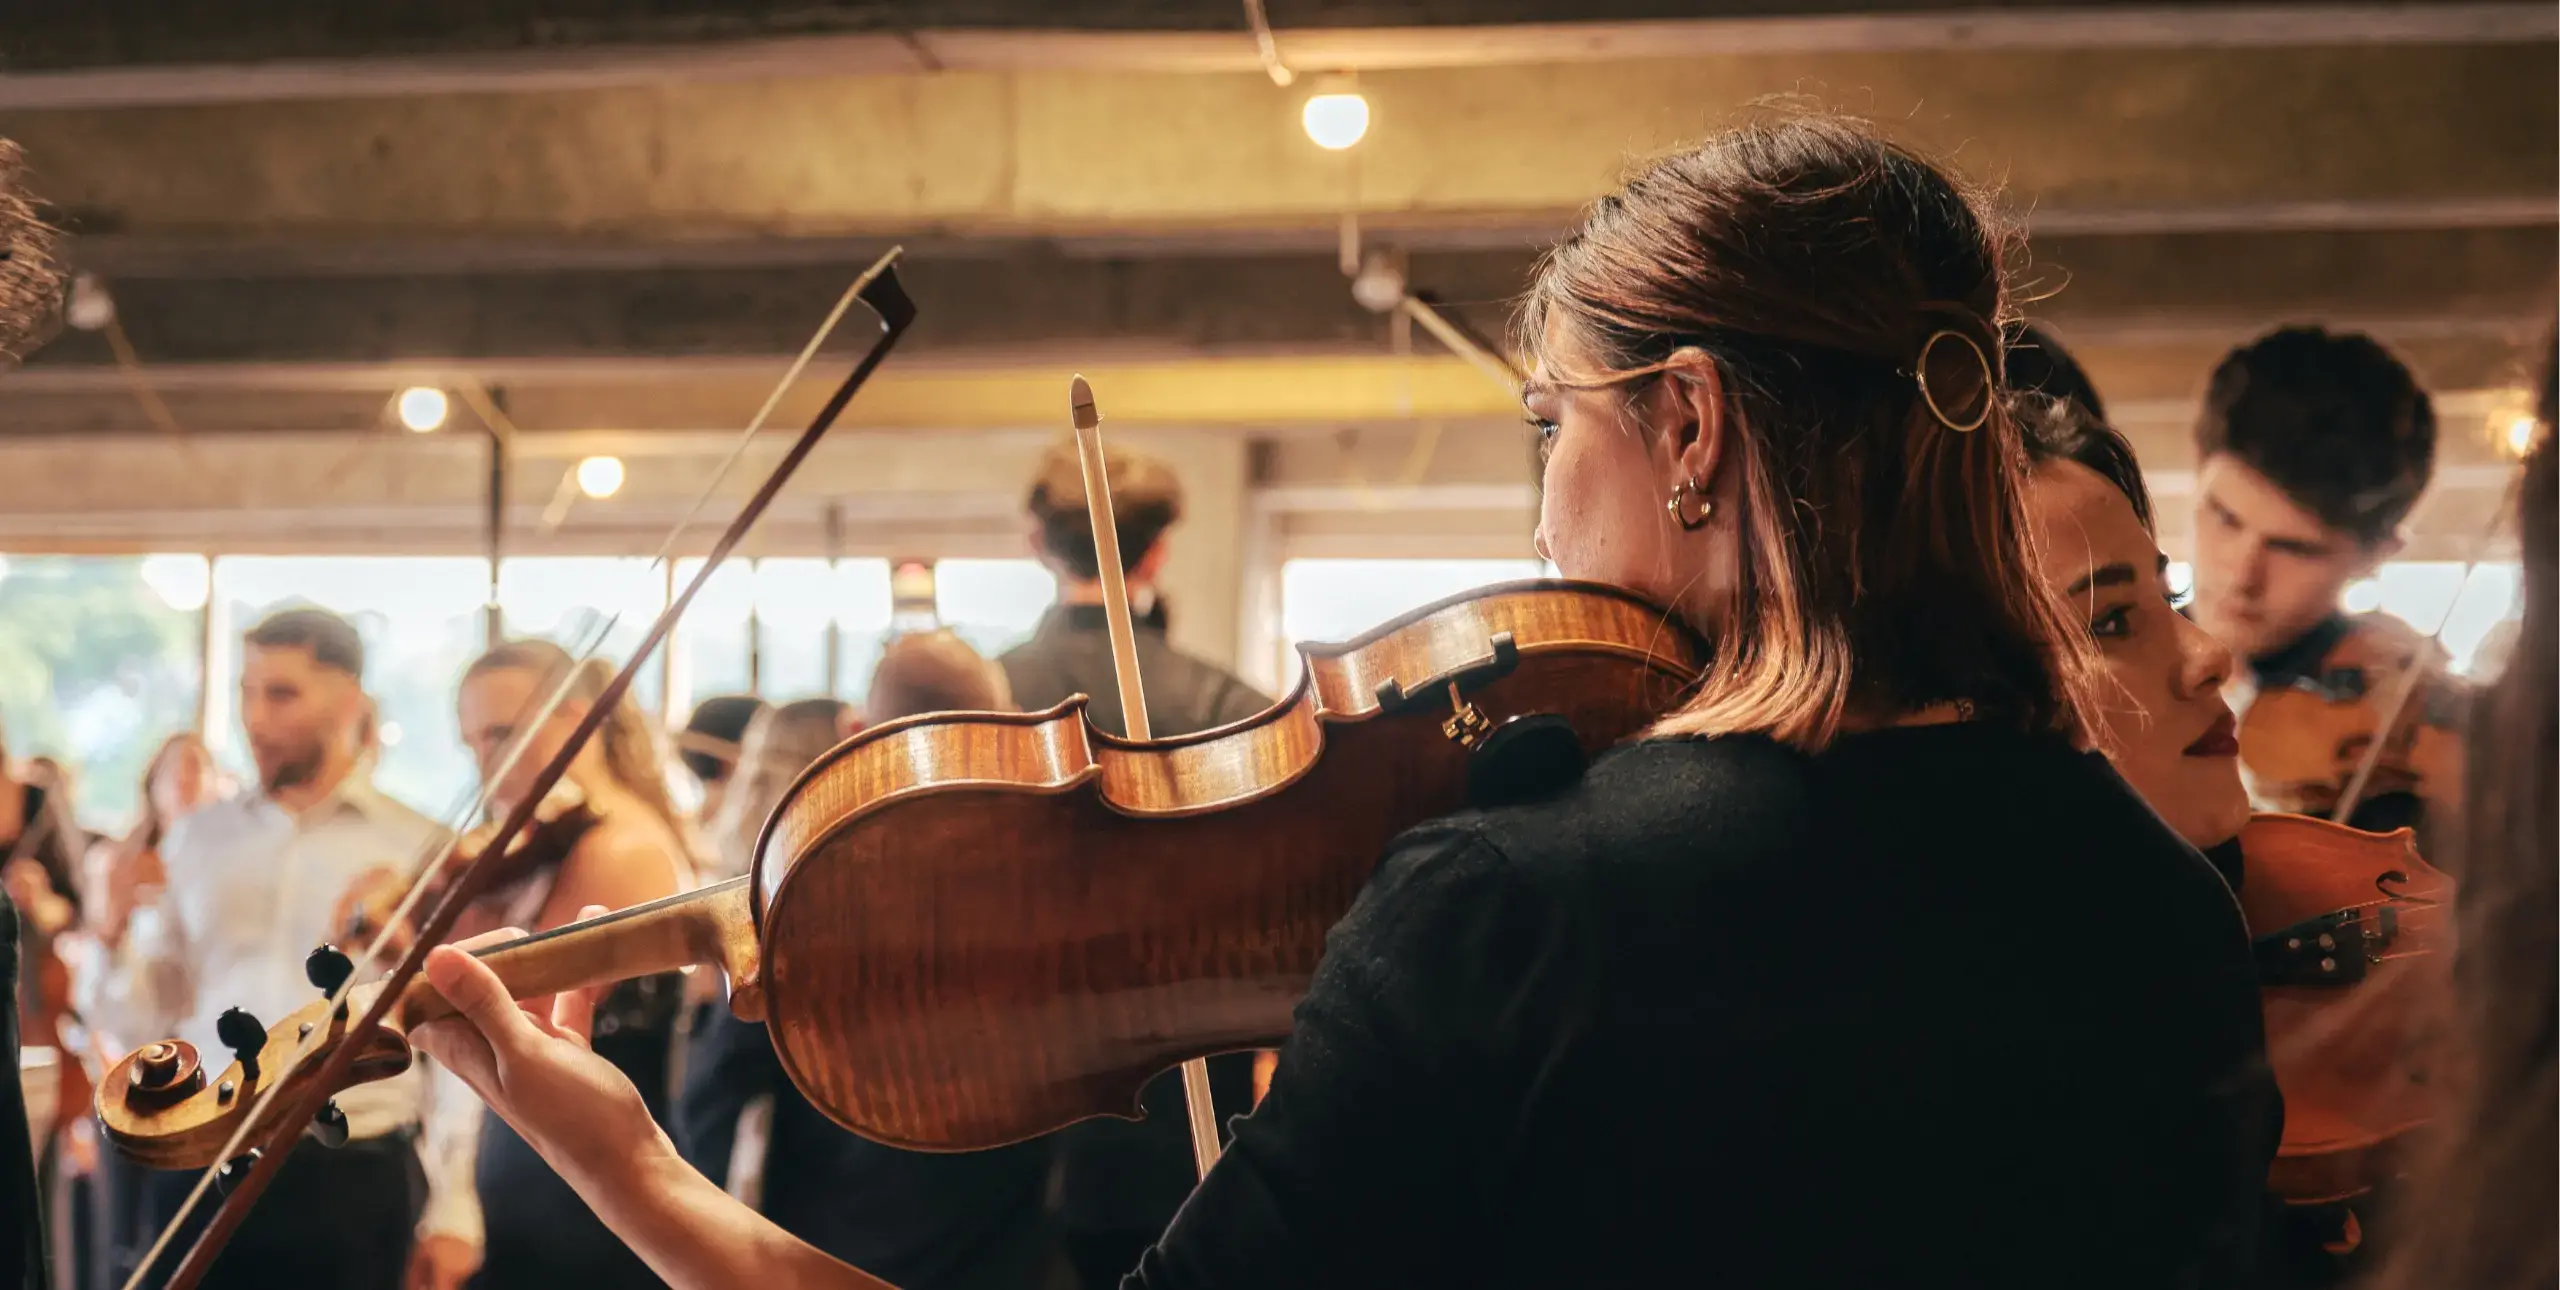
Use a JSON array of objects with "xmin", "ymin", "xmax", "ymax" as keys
[{"xmin": 97, "ymin": 581, "xmax": 1708, "ymax": 1167}]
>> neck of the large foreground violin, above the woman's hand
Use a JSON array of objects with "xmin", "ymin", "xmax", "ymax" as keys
[{"xmin": 399, "ymin": 878, "xmax": 758, "ymax": 1026}]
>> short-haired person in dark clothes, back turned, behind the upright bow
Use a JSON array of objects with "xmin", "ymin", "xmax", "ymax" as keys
[{"xmin": 996, "ymin": 440, "xmax": 1270, "ymax": 1290}]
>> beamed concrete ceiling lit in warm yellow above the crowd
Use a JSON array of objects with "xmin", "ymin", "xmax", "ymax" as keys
[{"xmin": 0, "ymin": 0, "xmax": 2560, "ymax": 560}]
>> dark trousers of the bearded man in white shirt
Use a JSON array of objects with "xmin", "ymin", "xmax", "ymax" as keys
[{"xmin": 118, "ymin": 1134, "xmax": 428, "ymax": 1290}]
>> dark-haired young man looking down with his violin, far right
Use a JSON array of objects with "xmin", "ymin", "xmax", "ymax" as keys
[{"xmin": 2189, "ymin": 328, "xmax": 2465, "ymax": 840}]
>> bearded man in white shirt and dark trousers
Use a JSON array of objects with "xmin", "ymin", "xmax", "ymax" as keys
[{"xmin": 83, "ymin": 609, "xmax": 438, "ymax": 1290}]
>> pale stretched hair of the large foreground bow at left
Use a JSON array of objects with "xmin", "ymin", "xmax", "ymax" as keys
[{"xmin": 123, "ymin": 262, "xmax": 899, "ymax": 1290}]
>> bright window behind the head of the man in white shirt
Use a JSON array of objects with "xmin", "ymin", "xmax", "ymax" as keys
[{"xmin": 205, "ymin": 555, "xmax": 489, "ymax": 819}]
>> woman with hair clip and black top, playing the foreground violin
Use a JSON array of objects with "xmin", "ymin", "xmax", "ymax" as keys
[{"xmin": 389, "ymin": 120, "xmax": 2278, "ymax": 1290}]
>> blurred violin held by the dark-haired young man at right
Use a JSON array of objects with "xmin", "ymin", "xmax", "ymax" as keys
[{"xmin": 2240, "ymin": 614, "xmax": 2465, "ymax": 819}]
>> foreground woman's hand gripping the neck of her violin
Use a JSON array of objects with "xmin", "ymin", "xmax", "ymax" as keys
[{"xmin": 410, "ymin": 906, "xmax": 671, "ymax": 1190}]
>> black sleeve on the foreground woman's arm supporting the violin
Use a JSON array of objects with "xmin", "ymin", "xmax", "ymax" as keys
[{"xmin": 1126, "ymin": 829, "xmax": 1590, "ymax": 1290}]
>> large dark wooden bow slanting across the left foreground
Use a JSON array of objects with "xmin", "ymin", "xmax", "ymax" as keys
[{"xmin": 125, "ymin": 248, "xmax": 916, "ymax": 1290}]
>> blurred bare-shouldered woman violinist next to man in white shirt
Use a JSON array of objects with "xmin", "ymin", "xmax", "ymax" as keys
[{"xmin": 410, "ymin": 640, "xmax": 694, "ymax": 1290}]
